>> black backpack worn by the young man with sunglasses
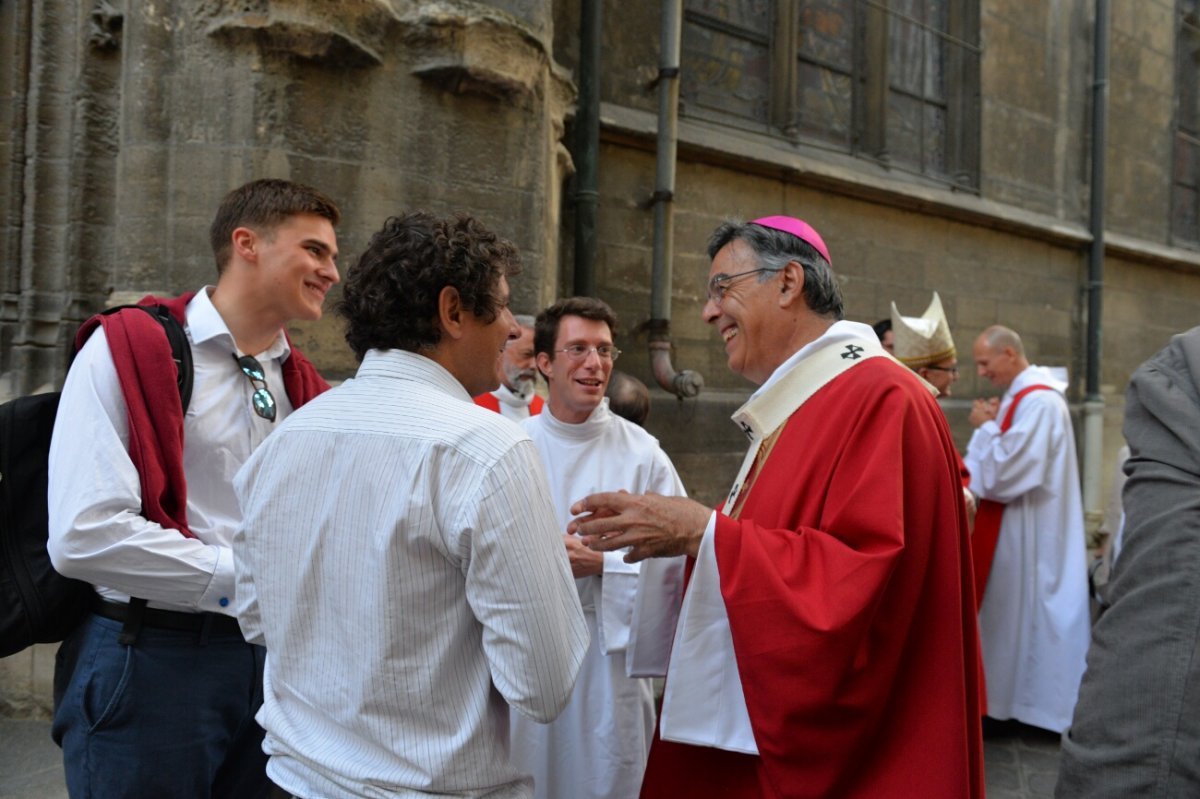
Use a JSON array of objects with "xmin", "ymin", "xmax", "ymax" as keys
[{"xmin": 0, "ymin": 305, "xmax": 192, "ymax": 657}]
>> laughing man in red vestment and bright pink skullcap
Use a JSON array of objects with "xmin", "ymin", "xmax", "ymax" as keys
[{"xmin": 569, "ymin": 216, "xmax": 984, "ymax": 799}]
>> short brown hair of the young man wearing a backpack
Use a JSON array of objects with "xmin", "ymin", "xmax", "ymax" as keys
[{"xmin": 209, "ymin": 178, "xmax": 342, "ymax": 275}]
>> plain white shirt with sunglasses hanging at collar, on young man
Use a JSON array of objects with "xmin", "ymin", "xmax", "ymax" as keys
[{"xmin": 47, "ymin": 287, "xmax": 292, "ymax": 615}]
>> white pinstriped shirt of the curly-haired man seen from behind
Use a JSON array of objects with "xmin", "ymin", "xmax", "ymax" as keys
[{"xmin": 234, "ymin": 350, "xmax": 588, "ymax": 797}]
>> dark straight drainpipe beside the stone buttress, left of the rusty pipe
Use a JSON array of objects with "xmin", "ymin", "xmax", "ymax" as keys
[{"xmin": 574, "ymin": 0, "xmax": 604, "ymax": 296}]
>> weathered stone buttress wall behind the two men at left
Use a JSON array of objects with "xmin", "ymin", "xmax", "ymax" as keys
[{"xmin": 0, "ymin": 0, "xmax": 574, "ymax": 390}]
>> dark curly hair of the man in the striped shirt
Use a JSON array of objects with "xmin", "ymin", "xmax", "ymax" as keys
[{"xmin": 337, "ymin": 211, "xmax": 521, "ymax": 361}]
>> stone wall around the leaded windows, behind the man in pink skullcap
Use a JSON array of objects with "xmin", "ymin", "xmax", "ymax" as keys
[{"xmin": 554, "ymin": 0, "xmax": 1200, "ymax": 511}]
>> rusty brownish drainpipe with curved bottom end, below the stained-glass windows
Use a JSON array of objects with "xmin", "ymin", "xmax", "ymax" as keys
[{"xmin": 646, "ymin": 0, "xmax": 704, "ymax": 400}]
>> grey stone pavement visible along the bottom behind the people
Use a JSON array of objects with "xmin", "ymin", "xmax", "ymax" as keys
[{"xmin": 7, "ymin": 719, "xmax": 1058, "ymax": 799}]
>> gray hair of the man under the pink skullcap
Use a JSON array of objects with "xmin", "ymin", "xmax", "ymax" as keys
[{"xmin": 708, "ymin": 220, "xmax": 845, "ymax": 320}]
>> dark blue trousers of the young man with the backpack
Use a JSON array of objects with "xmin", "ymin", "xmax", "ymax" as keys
[{"xmin": 53, "ymin": 615, "xmax": 271, "ymax": 799}]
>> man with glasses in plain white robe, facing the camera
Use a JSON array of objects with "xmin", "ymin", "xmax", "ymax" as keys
[{"xmin": 511, "ymin": 296, "xmax": 684, "ymax": 799}]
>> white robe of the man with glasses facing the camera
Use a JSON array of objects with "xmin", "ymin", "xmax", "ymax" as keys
[{"xmin": 510, "ymin": 400, "xmax": 684, "ymax": 799}]
